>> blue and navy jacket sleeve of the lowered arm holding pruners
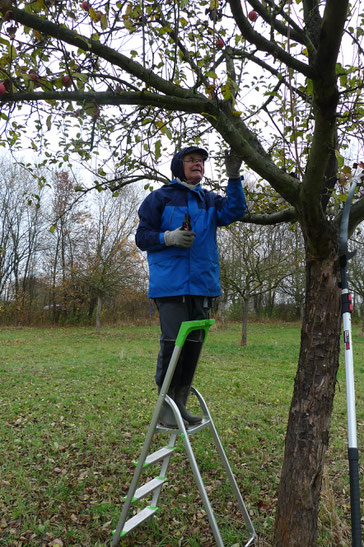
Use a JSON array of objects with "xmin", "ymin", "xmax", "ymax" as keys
[{"xmin": 135, "ymin": 190, "xmax": 165, "ymax": 251}]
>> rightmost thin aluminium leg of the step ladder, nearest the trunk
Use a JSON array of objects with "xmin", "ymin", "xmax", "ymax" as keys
[{"xmin": 191, "ymin": 387, "xmax": 256, "ymax": 547}]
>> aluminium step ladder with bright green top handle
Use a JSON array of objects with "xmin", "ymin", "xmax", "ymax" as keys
[{"xmin": 111, "ymin": 319, "xmax": 256, "ymax": 547}]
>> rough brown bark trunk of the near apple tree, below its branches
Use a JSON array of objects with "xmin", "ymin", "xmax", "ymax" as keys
[{"xmin": 274, "ymin": 252, "xmax": 341, "ymax": 547}]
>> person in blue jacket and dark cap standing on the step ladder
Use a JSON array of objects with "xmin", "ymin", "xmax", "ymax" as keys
[{"xmin": 135, "ymin": 146, "xmax": 246, "ymax": 427}]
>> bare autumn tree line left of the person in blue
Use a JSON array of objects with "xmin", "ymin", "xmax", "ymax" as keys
[{"xmin": 0, "ymin": 159, "xmax": 149, "ymax": 328}]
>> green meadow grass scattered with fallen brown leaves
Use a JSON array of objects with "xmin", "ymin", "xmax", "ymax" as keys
[{"xmin": 0, "ymin": 324, "xmax": 364, "ymax": 547}]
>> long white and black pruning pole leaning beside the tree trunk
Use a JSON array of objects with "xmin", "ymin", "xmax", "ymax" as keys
[{"xmin": 339, "ymin": 178, "xmax": 362, "ymax": 547}]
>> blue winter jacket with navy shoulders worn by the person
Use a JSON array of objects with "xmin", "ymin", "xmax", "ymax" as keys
[{"xmin": 135, "ymin": 178, "xmax": 246, "ymax": 298}]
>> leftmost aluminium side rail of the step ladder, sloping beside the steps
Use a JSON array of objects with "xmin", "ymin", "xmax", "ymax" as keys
[{"xmin": 111, "ymin": 345, "xmax": 182, "ymax": 547}]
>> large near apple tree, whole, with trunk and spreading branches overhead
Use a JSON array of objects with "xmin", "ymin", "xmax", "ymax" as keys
[{"xmin": 0, "ymin": 0, "xmax": 364, "ymax": 547}]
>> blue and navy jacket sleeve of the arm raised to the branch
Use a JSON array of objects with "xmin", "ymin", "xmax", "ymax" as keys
[{"xmin": 215, "ymin": 177, "xmax": 246, "ymax": 226}]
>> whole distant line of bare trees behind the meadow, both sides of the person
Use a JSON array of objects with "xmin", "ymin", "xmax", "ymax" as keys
[{"xmin": 0, "ymin": 158, "xmax": 364, "ymax": 332}]
